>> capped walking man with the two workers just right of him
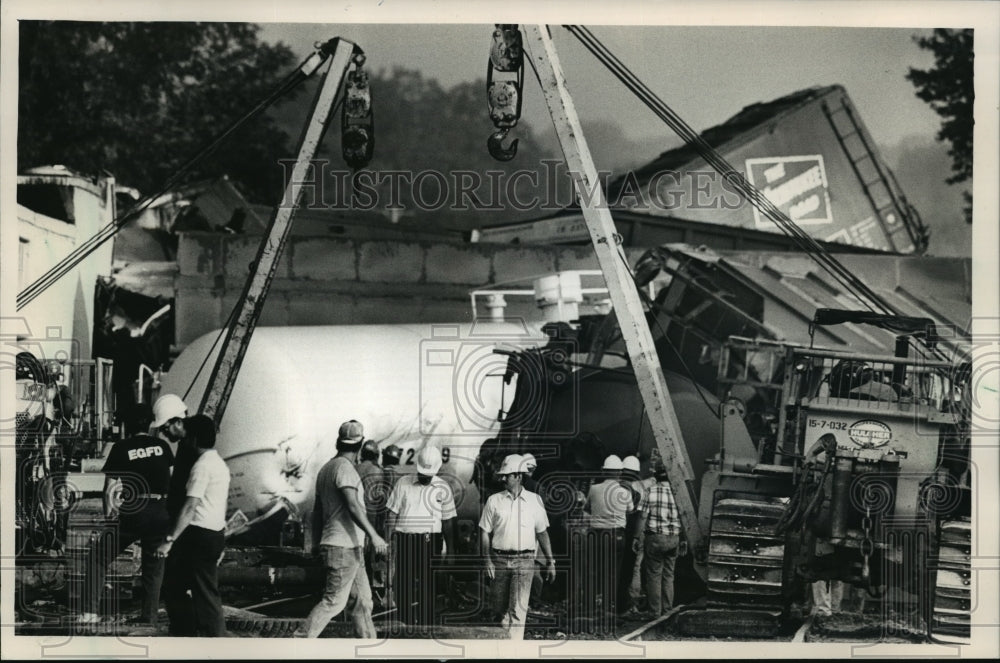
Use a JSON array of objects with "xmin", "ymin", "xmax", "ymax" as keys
[{"xmin": 296, "ymin": 420, "xmax": 458, "ymax": 638}]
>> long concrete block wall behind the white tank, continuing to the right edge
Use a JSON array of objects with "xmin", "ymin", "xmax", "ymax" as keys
[{"xmin": 175, "ymin": 233, "xmax": 971, "ymax": 347}]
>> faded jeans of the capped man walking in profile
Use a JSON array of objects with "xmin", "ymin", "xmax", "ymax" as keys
[{"xmin": 303, "ymin": 546, "xmax": 376, "ymax": 639}]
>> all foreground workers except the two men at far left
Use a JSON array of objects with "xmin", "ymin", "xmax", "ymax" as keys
[{"xmin": 296, "ymin": 420, "xmax": 682, "ymax": 639}]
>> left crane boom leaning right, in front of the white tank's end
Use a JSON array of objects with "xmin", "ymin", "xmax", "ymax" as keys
[{"xmin": 199, "ymin": 38, "xmax": 360, "ymax": 426}]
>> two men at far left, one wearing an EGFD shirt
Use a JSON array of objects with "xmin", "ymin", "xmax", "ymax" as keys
[{"xmin": 78, "ymin": 394, "xmax": 230, "ymax": 637}]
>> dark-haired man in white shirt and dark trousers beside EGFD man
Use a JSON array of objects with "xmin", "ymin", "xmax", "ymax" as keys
[{"xmin": 159, "ymin": 414, "xmax": 230, "ymax": 637}]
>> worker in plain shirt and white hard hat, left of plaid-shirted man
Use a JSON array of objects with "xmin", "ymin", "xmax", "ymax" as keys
[{"xmin": 584, "ymin": 454, "xmax": 635, "ymax": 632}]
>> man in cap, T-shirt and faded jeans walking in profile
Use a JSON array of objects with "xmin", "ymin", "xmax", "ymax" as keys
[{"xmin": 295, "ymin": 419, "xmax": 387, "ymax": 638}]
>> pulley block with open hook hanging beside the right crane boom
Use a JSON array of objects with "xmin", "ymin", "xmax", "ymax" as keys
[{"xmin": 486, "ymin": 23, "xmax": 524, "ymax": 161}]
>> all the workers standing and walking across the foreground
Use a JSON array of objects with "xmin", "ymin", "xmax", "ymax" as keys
[{"xmin": 79, "ymin": 394, "xmax": 681, "ymax": 639}]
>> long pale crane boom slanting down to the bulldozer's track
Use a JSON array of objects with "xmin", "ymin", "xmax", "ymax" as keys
[{"xmin": 525, "ymin": 25, "xmax": 704, "ymax": 551}]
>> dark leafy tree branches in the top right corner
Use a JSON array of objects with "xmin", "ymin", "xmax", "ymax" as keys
[{"xmin": 906, "ymin": 29, "xmax": 976, "ymax": 222}]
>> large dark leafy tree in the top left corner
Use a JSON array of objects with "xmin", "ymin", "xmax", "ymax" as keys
[{"xmin": 17, "ymin": 21, "xmax": 295, "ymax": 202}]
